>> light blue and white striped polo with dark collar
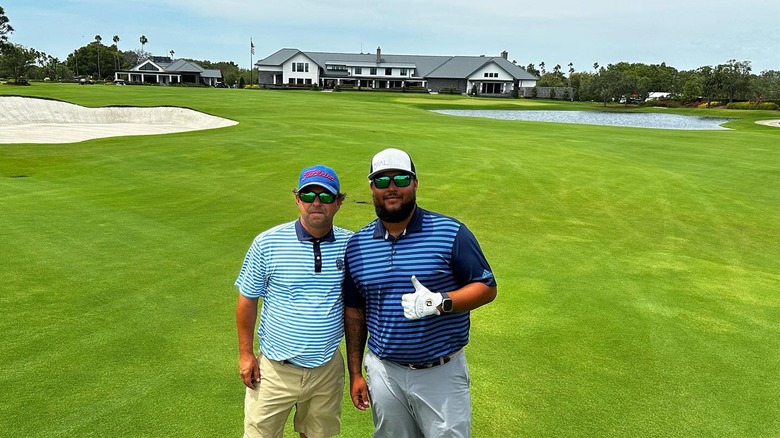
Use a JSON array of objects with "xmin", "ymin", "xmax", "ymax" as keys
[{"xmin": 235, "ymin": 220, "xmax": 353, "ymax": 368}]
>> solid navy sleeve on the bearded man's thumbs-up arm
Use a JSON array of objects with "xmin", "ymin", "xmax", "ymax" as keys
[{"xmin": 452, "ymin": 224, "xmax": 496, "ymax": 287}]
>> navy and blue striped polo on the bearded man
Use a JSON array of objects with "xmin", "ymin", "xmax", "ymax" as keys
[{"xmin": 344, "ymin": 206, "xmax": 496, "ymax": 363}]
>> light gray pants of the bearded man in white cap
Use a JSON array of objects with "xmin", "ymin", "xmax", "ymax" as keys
[{"xmin": 364, "ymin": 350, "xmax": 471, "ymax": 438}]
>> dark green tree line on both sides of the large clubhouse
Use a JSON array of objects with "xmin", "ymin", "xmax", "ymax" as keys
[{"xmin": 0, "ymin": 6, "xmax": 780, "ymax": 99}]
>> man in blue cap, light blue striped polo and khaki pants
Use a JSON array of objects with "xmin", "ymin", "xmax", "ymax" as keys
[{"xmin": 236, "ymin": 165, "xmax": 352, "ymax": 438}]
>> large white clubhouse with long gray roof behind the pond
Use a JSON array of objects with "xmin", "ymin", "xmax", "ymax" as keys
[{"xmin": 255, "ymin": 48, "xmax": 539, "ymax": 96}]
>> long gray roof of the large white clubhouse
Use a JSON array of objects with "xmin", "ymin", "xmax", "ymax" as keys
[{"xmin": 255, "ymin": 48, "xmax": 539, "ymax": 80}]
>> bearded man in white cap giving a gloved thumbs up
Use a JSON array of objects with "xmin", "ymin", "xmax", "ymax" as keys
[{"xmin": 344, "ymin": 149, "xmax": 496, "ymax": 438}]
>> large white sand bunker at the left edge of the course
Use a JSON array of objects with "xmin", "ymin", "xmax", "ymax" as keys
[{"xmin": 0, "ymin": 96, "xmax": 238, "ymax": 143}]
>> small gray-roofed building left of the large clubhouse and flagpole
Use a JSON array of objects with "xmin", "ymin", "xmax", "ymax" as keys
[{"xmin": 114, "ymin": 56, "xmax": 222, "ymax": 86}]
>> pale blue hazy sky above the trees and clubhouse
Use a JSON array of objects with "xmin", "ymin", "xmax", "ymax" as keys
[{"xmin": 0, "ymin": 0, "xmax": 780, "ymax": 73}]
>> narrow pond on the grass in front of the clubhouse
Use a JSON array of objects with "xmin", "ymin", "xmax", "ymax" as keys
[{"xmin": 433, "ymin": 110, "xmax": 729, "ymax": 130}]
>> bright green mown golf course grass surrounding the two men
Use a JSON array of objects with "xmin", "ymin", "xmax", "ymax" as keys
[{"xmin": 0, "ymin": 84, "xmax": 780, "ymax": 438}]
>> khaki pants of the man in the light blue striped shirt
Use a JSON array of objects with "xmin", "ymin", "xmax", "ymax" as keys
[{"xmin": 244, "ymin": 350, "xmax": 344, "ymax": 438}]
